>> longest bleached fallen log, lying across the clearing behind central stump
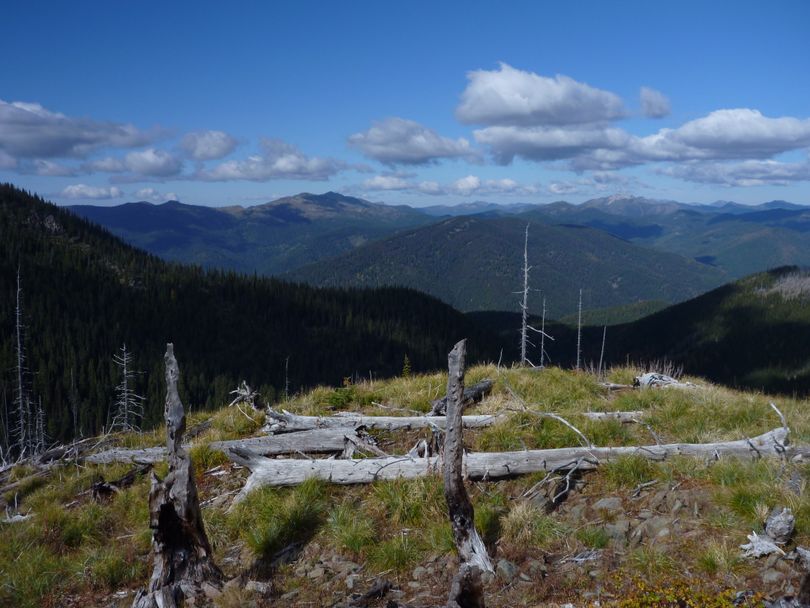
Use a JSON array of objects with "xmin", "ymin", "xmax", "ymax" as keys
[{"xmin": 227, "ymin": 427, "xmax": 784, "ymax": 500}]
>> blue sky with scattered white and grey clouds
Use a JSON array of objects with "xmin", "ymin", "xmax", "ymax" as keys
[{"xmin": 0, "ymin": 1, "xmax": 810, "ymax": 205}]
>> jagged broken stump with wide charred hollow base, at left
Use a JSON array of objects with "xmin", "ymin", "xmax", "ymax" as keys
[{"xmin": 132, "ymin": 344, "xmax": 222, "ymax": 608}]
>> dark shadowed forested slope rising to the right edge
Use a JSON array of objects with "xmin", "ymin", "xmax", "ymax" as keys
[{"xmin": 468, "ymin": 267, "xmax": 810, "ymax": 395}]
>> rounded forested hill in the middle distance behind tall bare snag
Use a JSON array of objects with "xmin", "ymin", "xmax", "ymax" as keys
[{"xmin": 286, "ymin": 216, "xmax": 724, "ymax": 317}]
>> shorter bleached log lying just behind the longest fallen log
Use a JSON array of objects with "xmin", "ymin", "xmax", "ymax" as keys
[{"xmin": 264, "ymin": 409, "xmax": 504, "ymax": 433}]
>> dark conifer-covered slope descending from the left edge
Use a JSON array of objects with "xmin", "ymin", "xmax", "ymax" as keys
[{"xmin": 0, "ymin": 184, "xmax": 500, "ymax": 442}]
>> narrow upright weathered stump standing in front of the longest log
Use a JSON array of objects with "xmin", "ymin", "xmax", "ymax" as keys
[{"xmin": 444, "ymin": 340, "xmax": 492, "ymax": 608}]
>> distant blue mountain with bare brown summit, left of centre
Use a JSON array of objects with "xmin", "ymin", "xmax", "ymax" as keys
[{"xmin": 70, "ymin": 192, "xmax": 434, "ymax": 275}]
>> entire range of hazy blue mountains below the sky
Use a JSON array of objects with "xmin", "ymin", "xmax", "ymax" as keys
[{"xmin": 71, "ymin": 192, "xmax": 810, "ymax": 315}]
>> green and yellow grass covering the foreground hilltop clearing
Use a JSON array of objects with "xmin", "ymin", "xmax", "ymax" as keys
[{"xmin": 0, "ymin": 365, "xmax": 810, "ymax": 608}]
